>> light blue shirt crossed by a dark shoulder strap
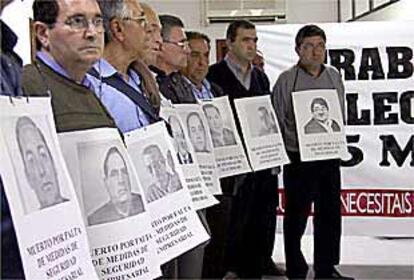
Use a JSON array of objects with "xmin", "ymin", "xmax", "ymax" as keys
[{"xmin": 87, "ymin": 59, "xmax": 150, "ymax": 133}]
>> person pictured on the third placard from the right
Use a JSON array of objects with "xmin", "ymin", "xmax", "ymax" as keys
[{"xmin": 203, "ymin": 104, "xmax": 237, "ymax": 148}]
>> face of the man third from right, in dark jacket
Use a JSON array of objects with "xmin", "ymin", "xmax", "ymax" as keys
[{"xmin": 183, "ymin": 39, "xmax": 210, "ymax": 84}]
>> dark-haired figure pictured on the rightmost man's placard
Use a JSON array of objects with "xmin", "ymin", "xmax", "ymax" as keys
[{"xmin": 304, "ymin": 97, "xmax": 341, "ymax": 134}]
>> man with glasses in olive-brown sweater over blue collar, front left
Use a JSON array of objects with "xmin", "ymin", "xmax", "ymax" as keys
[{"xmin": 23, "ymin": 0, "xmax": 115, "ymax": 132}]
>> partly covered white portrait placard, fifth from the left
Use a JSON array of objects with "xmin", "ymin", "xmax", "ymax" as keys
[{"xmin": 174, "ymin": 104, "xmax": 223, "ymax": 195}]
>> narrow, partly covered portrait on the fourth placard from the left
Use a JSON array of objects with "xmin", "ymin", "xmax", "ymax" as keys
[{"xmin": 168, "ymin": 116, "xmax": 194, "ymax": 164}]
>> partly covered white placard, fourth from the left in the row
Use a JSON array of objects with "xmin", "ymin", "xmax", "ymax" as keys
[{"xmin": 160, "ymin": 107, "xmax": 218, "ymax": 210}]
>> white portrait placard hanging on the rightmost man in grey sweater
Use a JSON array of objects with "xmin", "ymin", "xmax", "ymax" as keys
[{"xmin": 292, "ymin": 89, "xmax": 348, "ymax": 161}]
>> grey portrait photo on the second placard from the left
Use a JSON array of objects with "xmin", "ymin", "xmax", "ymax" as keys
[{"xmin": 78, "ymin": 142, "xmax": 145, "ymax": 226}]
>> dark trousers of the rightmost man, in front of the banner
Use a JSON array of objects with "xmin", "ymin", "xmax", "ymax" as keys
[{"xmin": 283, "ymin": 153, "xmax": 341, "ymax": 278}]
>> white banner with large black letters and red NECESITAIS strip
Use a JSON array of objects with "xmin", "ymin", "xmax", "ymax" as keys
[{"xmin": 258, "ymin": 22, "xmax": 414, "ymax": 235}]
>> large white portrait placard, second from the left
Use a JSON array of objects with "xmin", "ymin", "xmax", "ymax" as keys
[{"xmin": 59, "ymin": 128, "xmax": 161, "ymax": 279}]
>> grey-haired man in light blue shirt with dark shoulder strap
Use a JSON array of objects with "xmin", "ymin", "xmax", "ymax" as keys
[{"xmin": 89, "ymin": 0, "xmax": 158, "ymax": 133}]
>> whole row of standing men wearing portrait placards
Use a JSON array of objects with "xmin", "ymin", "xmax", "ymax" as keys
[{"xmin": 1, "ymin": 0, "xmax": 349, "ymax": 279}]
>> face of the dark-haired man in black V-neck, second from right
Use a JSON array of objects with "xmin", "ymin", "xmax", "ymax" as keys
[{"xmin": 229, "ymin": 28, "xmax": 257, "ymax": 63}]
